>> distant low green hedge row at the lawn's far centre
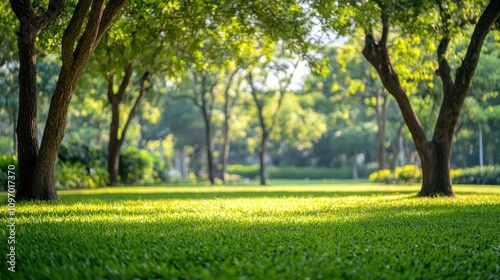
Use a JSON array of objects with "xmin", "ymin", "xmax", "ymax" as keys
[{"xmin": 227, "ymin": 165, "xmax": 373, "ymax": 180}]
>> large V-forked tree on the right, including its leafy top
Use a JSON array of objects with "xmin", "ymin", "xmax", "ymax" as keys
[{"xmin": 318, "ymin": 0, "xmax": 500, "ymax": 196}]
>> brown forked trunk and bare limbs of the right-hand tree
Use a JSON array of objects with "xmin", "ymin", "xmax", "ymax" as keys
[{"xmin": 363, "ymin": 0, "xmax": 500, "ymax": 196}]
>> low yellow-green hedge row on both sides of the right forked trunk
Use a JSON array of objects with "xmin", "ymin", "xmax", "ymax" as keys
[{"xmin": 368, "ymin": 165, "xmax": 500, "ymax": 185}]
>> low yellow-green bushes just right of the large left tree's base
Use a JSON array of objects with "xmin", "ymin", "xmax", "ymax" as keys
[{"xmin": 56, "ymin": 162, "xmax": 108, "ymax": 190}]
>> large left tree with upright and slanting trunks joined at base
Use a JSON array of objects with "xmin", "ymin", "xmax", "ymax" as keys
[{"xmin": 10, "ymin": 0, "xmax": 127, "ymax": 200}]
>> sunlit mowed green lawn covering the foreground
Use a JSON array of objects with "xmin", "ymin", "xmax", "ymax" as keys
[{"xmin": 0, "ymin": 183, "xmax": 500, "ymax": 279}]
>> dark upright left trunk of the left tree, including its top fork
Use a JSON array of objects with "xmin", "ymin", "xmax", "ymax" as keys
[{"xmin": 10, "ymin": 0, "xmax": 66, "ymax": 200}]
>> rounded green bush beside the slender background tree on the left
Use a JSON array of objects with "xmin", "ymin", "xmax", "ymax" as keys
[{"xmin": 119, "ymin": 147, "xmax": 167, "ymax": 184}]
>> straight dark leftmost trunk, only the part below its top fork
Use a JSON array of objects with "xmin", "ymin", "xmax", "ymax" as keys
[{"xmin": 16, "ymin": 22, "xmax": 40, "ymax": 200}]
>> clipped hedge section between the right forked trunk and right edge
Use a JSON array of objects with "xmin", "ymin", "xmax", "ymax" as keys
[{"xmin": 451, "ymin": 165, "xmax": 500, "ymax": 185}]
